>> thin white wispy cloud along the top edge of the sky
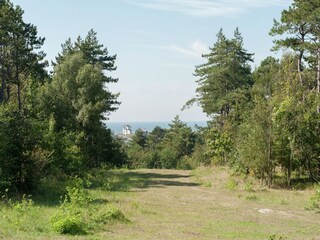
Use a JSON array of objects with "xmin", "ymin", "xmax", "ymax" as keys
[{"xmin": 126, "ymin": 0, "xmax": 292, "ymax": 17}]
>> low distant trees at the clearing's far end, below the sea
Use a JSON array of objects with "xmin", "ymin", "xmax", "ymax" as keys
[{"xmin": 124, "ymin": 116, "xmax": 207, "ymax": 169}]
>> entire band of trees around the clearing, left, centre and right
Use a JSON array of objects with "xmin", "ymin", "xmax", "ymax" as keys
[{"xmin": 0, "ymin": 0, "xmax": 320, "ymax": 192}]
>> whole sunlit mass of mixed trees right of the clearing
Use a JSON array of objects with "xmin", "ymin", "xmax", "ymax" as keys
[{"xmin": 187, "ymin": 0, "xmax": 320, "ymax": 186}]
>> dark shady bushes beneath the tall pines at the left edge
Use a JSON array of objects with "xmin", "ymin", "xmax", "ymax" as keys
[{"xmin": 0, "ymin": 105, "xmax": 49, "ymax": 192}]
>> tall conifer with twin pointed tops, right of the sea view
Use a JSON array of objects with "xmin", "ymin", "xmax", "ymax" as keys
[{"xmin": 187, "ymin": 29, "xmax": 253, "ymax": 122}]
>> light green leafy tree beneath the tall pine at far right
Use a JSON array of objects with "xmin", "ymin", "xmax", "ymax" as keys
[{"xmin": 273, "ymin": 55, "xmax": 317, "ymax": 187}]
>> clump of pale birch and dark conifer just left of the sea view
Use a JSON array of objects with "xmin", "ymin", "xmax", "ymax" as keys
[{"xmin": 38, "ymin": 31, "xmax": 122, "ymax": 174}]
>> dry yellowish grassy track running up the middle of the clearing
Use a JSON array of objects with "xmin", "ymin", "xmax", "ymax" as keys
[{"xmin": 104, "ymin": 170, "xmax": 320, "ymax": 240}]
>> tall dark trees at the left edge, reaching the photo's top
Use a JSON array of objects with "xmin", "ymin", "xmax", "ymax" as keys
[{"xmin": 0, "ymin": 0, "xmax": 50, "ymax": 192}]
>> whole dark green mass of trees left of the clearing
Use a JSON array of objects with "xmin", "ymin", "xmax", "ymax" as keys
[{"xmin": 0, "ymin": 0, "xmax": 125, "ymax": 192}]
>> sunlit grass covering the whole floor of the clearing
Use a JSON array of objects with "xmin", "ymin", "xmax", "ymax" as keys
[{"xmin": 0, "ymin": 167, "xmax": 319, "ymax": 240}]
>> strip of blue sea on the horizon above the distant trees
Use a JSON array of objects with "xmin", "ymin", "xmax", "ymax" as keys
[{"xmin": 106, "ymin": 121, "xmax": 207, "ymax": 134}]
